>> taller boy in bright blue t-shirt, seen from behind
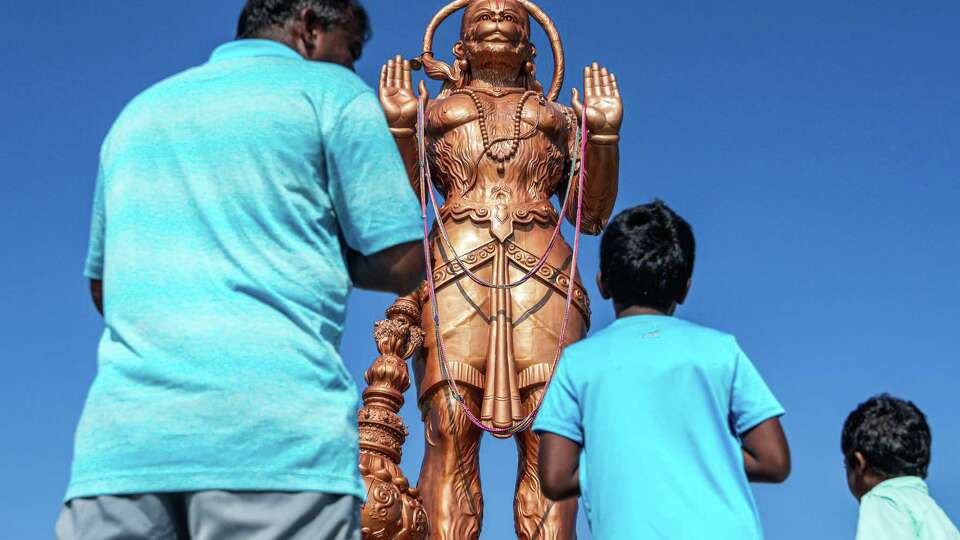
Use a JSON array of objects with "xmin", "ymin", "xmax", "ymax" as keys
[{"xmin": 533, "ymin": 201, "xmax": 790, "ymax": 540}]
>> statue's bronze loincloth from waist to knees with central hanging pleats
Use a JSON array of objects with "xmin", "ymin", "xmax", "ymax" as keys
[{"xmin": 418, "ymin": 201, "xmax": 590, "ymax": 436}]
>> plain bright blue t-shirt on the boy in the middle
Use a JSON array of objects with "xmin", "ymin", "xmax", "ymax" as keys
[{"xmin": 533, "ymin": 315, "xmax": 784, "ymax": 540}]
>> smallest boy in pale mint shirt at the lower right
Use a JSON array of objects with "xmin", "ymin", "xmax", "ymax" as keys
[{"xmin": 840, "ymin": 394, "xmax": 960, "ymax": 540}]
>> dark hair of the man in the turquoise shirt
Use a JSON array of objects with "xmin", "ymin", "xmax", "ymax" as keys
[{"xmin": 237, "ymin": 0, "xmax": 371, "ymax": 42}]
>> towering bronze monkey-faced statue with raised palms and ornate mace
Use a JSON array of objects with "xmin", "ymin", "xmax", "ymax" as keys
[{"xmin": 361, "ymin": 0, "xmax": 623, "ymax": 540}]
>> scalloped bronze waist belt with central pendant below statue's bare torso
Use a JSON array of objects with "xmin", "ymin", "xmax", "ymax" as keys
[{"xmin": 440, "ymin": 200, "xmax": 559, "ymax": 242}]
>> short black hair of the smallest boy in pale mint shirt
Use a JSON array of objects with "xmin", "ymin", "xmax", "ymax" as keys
[{"xmin": 840, "ymin": 394, "xmax": 932, "ymax": 478}]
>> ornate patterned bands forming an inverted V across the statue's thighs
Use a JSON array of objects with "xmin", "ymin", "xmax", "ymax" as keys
[{"xmin": 433, "ymin": 239, "xmax": 590, "ymax": 321}]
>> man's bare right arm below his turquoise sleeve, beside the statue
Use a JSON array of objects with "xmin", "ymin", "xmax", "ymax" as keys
[{"xmin": 347, "ymin": 241, "xmax": 424, "ymax": 295}]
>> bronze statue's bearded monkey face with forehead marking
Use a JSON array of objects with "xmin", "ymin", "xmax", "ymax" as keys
[{"xmin": 460, "ymin": 0, "xmax": 533, "ymax": 70}]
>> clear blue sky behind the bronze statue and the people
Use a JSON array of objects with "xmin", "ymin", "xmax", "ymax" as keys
[{"xmin": 0, "ymin": 0, "xmax": 960, "ymax": 540}]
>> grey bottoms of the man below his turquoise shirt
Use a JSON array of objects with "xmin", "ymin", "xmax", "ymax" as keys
[{"xmin": 57, "ymin": 491, "xmax": 360, "ymax": 540}]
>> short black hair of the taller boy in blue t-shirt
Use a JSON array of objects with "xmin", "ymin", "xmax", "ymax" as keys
[{"xmin": 600, "ymin": 199, "xmax": 696, "ymax": 311}]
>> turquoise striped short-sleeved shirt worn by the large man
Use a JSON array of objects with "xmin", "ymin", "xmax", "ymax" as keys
[{"xmin": 66, "ymin": 40, "xmax": 423, "ymax": 500}]
